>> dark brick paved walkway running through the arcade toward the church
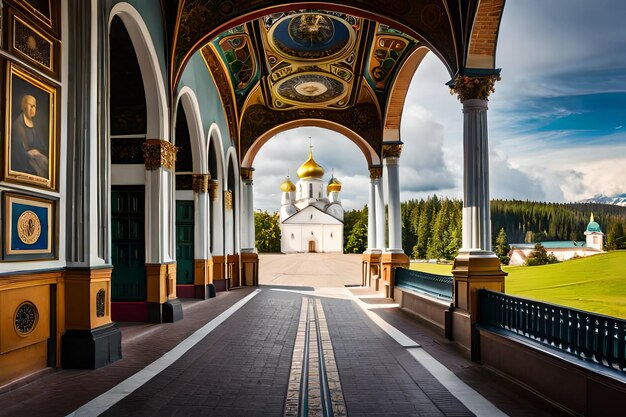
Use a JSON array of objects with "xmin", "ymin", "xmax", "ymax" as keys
[{"xmin": 0, "ymin": 252, "xmax": 560, "ymax": 417}]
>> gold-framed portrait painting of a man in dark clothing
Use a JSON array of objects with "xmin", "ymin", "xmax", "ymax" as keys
[{"xmin": 4, "ymin": 62, "xmax": 57, "ymax": 189}]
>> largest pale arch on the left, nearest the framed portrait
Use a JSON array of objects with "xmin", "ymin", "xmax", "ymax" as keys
[{"xmin": 108, "ymin": 3, "xmax": 170, "ymax": 141}]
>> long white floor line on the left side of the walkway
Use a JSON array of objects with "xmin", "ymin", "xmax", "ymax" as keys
[{"xmin": 68, "ymin": 289, "xmax": 261, "ymax": 417}]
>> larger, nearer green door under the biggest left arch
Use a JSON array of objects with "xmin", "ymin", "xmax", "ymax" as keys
[{"xmin": 111, "ymin": 186, "xmax": 146, "ymax": 301}]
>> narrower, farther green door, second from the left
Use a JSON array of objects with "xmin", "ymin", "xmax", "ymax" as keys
[{"xmin": 176, "ymin": 201, "xmax": 194, "ymax": 284}]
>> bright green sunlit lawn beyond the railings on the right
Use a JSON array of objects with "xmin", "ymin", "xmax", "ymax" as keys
[{"xmin": 411, "ymin": 251, "xmax": 626, "ymax": 319}]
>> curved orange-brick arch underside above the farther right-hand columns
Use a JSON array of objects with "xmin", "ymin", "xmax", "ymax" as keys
[{"xmin": 383, "ymin": 46, "xmax": 429, "ymax": 141}]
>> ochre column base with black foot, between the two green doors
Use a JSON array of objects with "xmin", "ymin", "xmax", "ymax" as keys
[{"xmin": 146, "ymin": 262, "xmax": 183, "ymax": 323}]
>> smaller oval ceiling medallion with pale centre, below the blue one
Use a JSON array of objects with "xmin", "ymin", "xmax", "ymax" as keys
[{"xmin": 276, "ymin": 74, "xmax": 345, "ymax": 104}]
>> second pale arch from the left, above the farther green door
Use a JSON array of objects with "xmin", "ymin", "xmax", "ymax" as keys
[{"xmin": 173, "ymin": 87, "xmax": 209, "ymax": 174}]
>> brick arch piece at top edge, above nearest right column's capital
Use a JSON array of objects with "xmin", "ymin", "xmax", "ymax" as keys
[{"xmin": 465, "ymin": 0, "xmax": 504, "ymax": 69}]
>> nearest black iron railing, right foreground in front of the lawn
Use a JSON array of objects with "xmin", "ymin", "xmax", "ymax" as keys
[{"xmin": 479, "ymin": 290, "xmax": 626, "ymax": 371}]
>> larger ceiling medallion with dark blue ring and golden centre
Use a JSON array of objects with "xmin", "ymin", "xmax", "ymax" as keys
[{"xmin": 269, "ymin": 12, "xmax": 355, "ymax": 60}]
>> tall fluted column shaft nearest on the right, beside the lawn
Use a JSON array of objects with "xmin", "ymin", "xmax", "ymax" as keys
[{"xmin": 462, "ymin": 99, "xmax": 491, "ymax": 251}]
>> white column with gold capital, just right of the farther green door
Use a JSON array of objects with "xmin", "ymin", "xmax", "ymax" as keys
[{"xmin": 193, "ymin": 174, "xmax": 211, "ymax": 259}]
